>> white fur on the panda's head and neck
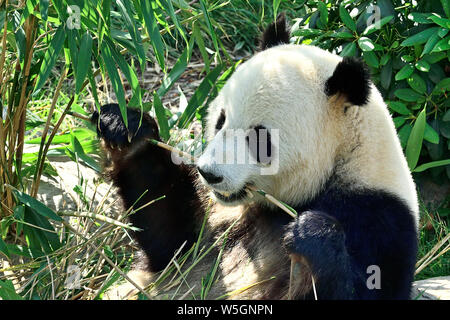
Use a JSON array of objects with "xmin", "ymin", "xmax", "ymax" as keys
[{"xmin": 199, "ymin": 45, "xmax": 418, "ymax": 225}]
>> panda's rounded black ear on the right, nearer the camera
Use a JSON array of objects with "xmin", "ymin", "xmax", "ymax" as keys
[{"xmin": 325, "ymin": 57, "xmax": 370, "ymax": 106}]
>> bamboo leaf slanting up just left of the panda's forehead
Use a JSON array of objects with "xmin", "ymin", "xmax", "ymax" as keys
[{"xmin": 178, "ymin": 64, "xmax": 224, "ymax": 128}]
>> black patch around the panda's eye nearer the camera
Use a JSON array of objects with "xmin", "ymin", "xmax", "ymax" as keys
[{"xmin": 246, "ymin": 125, "xmax": 272, "ymax": 164}]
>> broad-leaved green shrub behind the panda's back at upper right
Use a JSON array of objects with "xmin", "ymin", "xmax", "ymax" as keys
[{"xmin": 293, "ymin": 0, "xmax": 450, "ymax": 183}]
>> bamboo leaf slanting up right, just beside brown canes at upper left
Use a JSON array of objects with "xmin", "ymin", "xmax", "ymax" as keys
[{"xmin": 34, "ymin": 24, "xmax": 66, "ymax": 94}]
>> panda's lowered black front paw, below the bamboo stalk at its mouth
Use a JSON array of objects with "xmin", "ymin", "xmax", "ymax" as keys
[{"xmin": 284, "ymin": 211, "xmax": 346, "ymax": 271}]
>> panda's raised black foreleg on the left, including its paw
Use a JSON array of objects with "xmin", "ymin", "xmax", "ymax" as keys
[{"xmin": 92, "ymin": 104, "xmax": 201, "ymax": 272}]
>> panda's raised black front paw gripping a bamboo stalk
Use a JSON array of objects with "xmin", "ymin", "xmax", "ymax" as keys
[{"xmin": 91, "ymin": 104, "xmax": 159, "ymax": 149}]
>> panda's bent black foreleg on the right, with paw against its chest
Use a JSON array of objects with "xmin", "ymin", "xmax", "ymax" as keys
[{"xmin": 284, "ymin": 211, "xmax": 359, "ymax": 300}]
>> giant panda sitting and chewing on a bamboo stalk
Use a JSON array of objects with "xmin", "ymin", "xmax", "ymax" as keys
[{"xmin": 92, "ymin": 16, "xmax": 419, "ymax": 300}]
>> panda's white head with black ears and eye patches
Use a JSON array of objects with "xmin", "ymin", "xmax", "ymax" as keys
[{"xmin": 197, "ymin": 17, "xmax": 410, "ymax": 209}]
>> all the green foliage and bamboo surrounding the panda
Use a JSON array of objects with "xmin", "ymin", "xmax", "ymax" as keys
[{"xmin": 0, "ymin": 0, "xmax": 450, "ymax": 299}]
